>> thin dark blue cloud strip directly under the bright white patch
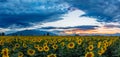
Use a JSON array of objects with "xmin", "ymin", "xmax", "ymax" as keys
[{"xmin": 41, "ymin": 25, "xmax": 99, "ymax": 30}]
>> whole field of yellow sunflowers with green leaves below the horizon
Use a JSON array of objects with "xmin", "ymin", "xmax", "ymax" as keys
[{"xmin": 0, "ymin": 36, "xmax": 120, "ymax": 57}]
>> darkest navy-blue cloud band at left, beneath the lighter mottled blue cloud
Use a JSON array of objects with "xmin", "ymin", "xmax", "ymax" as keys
[{"xmin": 0, "ymin": 13, "xmax": 60, "ymax": 28}]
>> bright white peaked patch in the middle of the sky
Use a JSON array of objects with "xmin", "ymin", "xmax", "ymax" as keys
[{"xmin": 41, "ymin": 9, "xmax": 101, "ymax": 27}]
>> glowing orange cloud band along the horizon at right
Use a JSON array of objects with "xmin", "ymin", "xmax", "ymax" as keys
[{"xmin": 64, "ymin": 26, "xmax": 120, "ymax": 34}]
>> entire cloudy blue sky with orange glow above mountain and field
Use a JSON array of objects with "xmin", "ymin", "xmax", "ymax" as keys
[{"xmin": 0, "ymin": 0, "xmax": 120, "ymax": 34}]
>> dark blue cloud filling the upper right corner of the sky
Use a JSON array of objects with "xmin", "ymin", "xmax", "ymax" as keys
[{"xmin": 67, "ymin": 0, "xmax": 120, "ymax": 23}]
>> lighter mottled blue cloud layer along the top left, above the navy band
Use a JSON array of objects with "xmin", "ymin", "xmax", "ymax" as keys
[{"xmin": 0, "ymin": 0, "xmax": 69, "ymax": 14}]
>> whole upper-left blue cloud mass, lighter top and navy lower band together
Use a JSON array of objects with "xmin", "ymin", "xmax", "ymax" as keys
[{"xmin": 0, "ymin": 0, "xmax": 67, "ymax": 28}]
